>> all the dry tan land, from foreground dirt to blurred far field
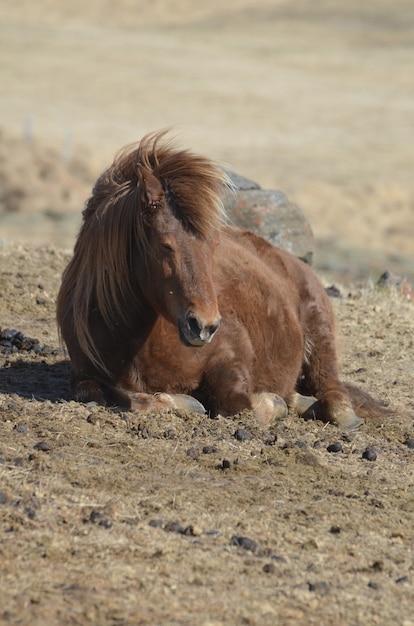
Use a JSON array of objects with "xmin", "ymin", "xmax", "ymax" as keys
[{"xmin": 0, "ymin": 0, "xmax": 414, "ymax": 626}]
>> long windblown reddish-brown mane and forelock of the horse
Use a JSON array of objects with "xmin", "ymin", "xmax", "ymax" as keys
[{"xmin": 57, "ymin": 130, "xmax": 231, "ymax": 375}]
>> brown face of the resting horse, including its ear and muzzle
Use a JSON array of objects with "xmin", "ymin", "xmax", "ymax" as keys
[{"xmin": 136, "ymin": 161, "xmax": 221, "ymax": 347}]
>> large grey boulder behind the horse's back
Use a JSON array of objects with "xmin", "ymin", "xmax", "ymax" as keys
[{"xmin": 224, "ymin": 171, "xmax": 314, "ymax": 263}]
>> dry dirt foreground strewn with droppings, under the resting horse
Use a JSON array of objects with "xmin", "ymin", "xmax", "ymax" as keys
[{"xmin": 0, "ymin": 246, "xmax": 414, "ymax": 626}]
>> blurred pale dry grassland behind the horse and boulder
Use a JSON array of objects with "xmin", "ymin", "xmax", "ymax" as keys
[{"xmin": 0, "ymin": 0, "xmax": 414, "ymax": 281}]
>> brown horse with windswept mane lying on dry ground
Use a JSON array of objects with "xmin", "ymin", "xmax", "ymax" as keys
[{"xmin": 57, "ymin": 132, "xmax": 384, "ymax": 428}]
